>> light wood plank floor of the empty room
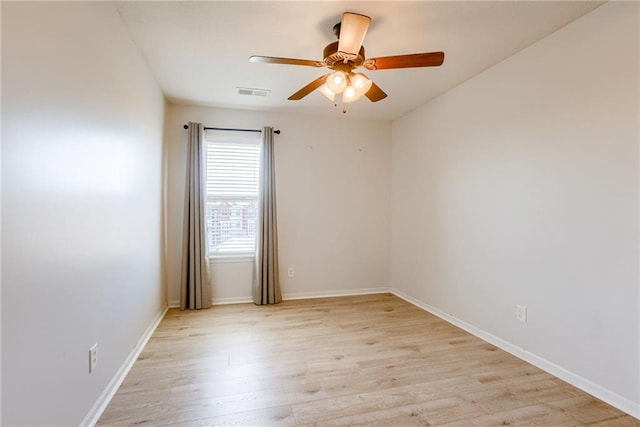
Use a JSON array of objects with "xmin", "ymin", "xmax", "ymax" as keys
[{"xmin": 99, "ymin": 294, "xmax": 640, "ymax": 427}]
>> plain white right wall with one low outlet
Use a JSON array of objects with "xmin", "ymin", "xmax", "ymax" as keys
[{"xmin": 392, "ymin": 2, "xmax": 640, "ymax": 416}]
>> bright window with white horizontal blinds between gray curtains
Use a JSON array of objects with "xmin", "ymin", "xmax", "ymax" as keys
[{"xmin": 206, "ymin": 132, "xmax": 260, "ymax": 257}]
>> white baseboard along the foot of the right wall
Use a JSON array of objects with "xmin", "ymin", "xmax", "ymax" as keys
[{"xmin": 390, "ymin": 288, "xmax": 640, "ymax": 419}]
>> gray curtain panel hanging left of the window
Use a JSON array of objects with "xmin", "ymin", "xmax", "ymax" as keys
[{"xmin": 180, "ymin": 122, "xmax": 211, "ymax": 310}]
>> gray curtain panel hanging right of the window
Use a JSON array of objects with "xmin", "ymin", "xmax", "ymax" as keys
[{"xmin": 253, "ymin": 127, "xmax": 282, "ymax": 305}]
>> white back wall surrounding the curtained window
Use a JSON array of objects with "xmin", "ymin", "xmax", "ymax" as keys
[{"xmin": 166, "ymin": 105, "xmax": 391, "ymax": 304}]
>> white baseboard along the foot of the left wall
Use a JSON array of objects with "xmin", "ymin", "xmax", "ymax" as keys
[{"xmin": 80, "ymin": 306, "xmax": 169, "ymax": 426}]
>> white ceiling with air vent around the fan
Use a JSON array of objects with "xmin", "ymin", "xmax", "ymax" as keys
[{"xmin": 116, "ymin": 1, "xmax": 602, "ymax": 120}]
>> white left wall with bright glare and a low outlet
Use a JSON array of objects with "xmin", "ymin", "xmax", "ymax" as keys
[{"xmin": 2, "ymin": 2, "xmax": 166, "ymax": 426}]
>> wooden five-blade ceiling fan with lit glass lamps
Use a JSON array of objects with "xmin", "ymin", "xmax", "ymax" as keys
[{"xmin": 249, "ymin": 12, "xmax": 444, "ymax": 103}]
